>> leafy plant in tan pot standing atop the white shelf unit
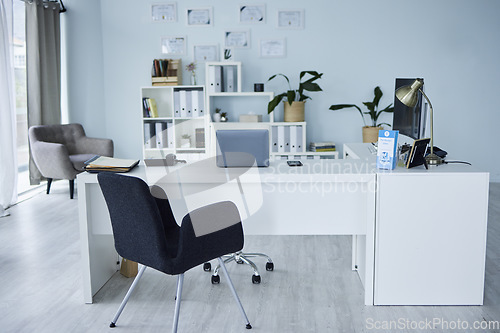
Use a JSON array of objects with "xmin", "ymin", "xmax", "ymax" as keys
[{"xmin": 267, "ymin": 71, "xmax": 323, "ymax": 121}]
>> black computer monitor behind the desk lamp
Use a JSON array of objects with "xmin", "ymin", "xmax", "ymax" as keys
[{"xmin": 392, "ymin": 78, "xmax": 427, "ymax": 140}]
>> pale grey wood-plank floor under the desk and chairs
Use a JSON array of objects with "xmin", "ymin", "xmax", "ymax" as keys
[{"xmin": 0, "ymin": 182, "xmax": 500, "ymax": 333}]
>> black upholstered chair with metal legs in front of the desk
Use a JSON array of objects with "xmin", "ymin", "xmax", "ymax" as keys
[{"xmin": 97, "ymin": 172, "xmax": 252, "ymax": 332}]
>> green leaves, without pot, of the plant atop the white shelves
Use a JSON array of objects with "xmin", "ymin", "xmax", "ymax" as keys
[{"xmin": 267, "ymin": 71, "xmax": 323, "ymax": 113}]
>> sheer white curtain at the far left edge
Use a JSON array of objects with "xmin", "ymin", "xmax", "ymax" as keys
[{"xmin": 0, "ymin": 0, "xmax": 17, "ymax": 217}]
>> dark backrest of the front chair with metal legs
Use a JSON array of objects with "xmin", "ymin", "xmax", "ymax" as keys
[{"xmin": 97, "ymin": 172, "xmax": 169, "ymax": 268}]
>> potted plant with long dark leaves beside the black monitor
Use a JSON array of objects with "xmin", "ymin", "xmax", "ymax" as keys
[{"xmin": 330, "ymin": 86, "xmax": 394, "ymax": 142}]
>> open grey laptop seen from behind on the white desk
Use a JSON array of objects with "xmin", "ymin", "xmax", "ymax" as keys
[{"xmin": 215, "ymin": 129, "xmax": 269, "ymax": 168}]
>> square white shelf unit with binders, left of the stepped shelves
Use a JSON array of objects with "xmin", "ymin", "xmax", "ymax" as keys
[{"xmin": 141, "ymin": 86, "xmax": 208, "ymax": 160}]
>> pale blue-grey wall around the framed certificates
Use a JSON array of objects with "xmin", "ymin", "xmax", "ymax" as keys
[{"xmin": 64, "ymin": 0, "xmax": 500, "ymax": 181}]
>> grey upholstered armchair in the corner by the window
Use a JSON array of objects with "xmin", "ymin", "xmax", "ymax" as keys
[{"xmin": 28, "ymin": 124, "xmax": 113, "ymax": 199}]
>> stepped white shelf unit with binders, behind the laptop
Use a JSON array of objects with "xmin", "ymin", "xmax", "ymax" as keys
[{"xmin": 205, "ymin": 61, "xmax": 338, "ymax": 159}]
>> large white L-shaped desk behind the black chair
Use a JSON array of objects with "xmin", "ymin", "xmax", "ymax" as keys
[{"xmin": 78, "ymin": 145, "xmax": 488, "ymax": 305}]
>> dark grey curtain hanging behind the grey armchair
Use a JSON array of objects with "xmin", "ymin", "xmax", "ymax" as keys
[{"xmin": 26, "ymin": 0, "xmax": 61, "ymax": 185}]
